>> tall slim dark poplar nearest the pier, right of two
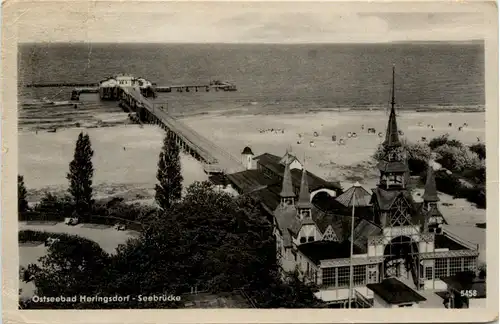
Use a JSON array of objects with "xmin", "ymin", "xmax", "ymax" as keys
[{"xmin": 155, "ymin": 131, "xmax": 183, "ymax": 210}]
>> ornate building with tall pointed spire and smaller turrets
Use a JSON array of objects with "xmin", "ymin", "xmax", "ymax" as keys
[{"xmin": 210, "ymin": 69, "xmax": 479, "ymax": 307}]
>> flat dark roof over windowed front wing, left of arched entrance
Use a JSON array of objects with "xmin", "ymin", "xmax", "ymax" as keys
[{"xmin": 297, "ymin": 241, "xmax": 362, "ymax": 264}]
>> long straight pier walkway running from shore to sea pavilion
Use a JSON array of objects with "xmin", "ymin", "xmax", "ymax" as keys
[{"xmin": 122, "ymin": 87, "xmax": 244, "ymax": 174}]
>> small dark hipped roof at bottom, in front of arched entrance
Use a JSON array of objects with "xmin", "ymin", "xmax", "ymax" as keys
[{"xmin": 366, "ymin": 278, "xmax": 427, "ymax": 305}]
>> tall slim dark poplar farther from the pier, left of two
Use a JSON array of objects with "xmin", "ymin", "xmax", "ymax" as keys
[{"xmin": 66, "ymin": 132, "xmax": 94, "ymax": 216}]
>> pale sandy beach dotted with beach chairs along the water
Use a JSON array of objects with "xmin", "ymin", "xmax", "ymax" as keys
[{"xmin": 19, "ymin": 106, "xmax": 485, "ymax": 226}]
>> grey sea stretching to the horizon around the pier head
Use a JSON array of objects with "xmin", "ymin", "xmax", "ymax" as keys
[{"xmin": 18, "ymin": 42, "xmax": 485, "ymax": 113}]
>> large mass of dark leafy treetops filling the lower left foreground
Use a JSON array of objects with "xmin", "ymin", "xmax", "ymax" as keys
[{"xmin": 22, "ymin": 182, "xmax": 318, "ymax": 308}]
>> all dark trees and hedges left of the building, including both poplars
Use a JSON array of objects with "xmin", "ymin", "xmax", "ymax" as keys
[{"xmin": 19, "ymin": 130, "xmax": 322, "ymax": 308}]
